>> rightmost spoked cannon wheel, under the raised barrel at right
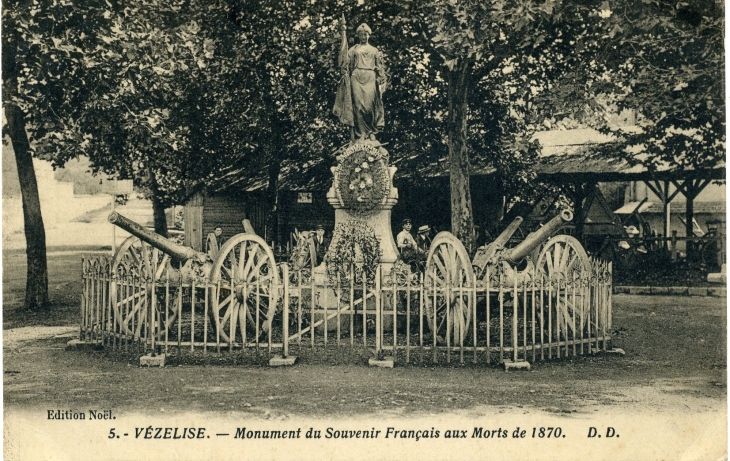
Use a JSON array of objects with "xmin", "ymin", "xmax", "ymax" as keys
[{"xmin": 535, "ymin": 235, "xmax": 591, "ymax": 335}]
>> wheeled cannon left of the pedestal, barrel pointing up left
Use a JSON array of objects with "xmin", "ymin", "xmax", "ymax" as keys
[{"xmin": 109, "ymin": 212, "xmax": 280, "ymax": 342}]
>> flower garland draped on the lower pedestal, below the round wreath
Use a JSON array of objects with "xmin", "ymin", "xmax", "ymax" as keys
[{"xmin": 324, "ymin": 221, "xmax": 380, "ymax": 284}]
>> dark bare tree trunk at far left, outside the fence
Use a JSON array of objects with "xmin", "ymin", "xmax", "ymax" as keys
[{"xmin": 5, "ymin": 104, "xmax": 48, "ymax": 309}]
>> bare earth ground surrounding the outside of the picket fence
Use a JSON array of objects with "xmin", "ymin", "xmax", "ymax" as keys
[{"xmin": 4, "ymin": 285, "xmax": 727, "ymax": 417}]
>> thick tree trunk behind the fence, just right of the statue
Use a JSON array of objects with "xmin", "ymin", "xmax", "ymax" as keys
[{"xmin": 447, "ymin": 59, "xmax": 474, "ymax": 254}]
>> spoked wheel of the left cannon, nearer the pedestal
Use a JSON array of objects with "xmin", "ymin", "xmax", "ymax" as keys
[{"xmin": 210, "ymin": 234, "xmax": 280, "ymax": 342}]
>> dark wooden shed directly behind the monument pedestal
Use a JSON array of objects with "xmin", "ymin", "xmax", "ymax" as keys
[{"xmin": 184, "ymin": 167, "xmax": 502, "ymax": 249}]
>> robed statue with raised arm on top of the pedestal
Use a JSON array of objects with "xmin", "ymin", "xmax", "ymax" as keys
[{"xmin": 332, "ymin": 16, "xmax": 386, "ymax": 140}]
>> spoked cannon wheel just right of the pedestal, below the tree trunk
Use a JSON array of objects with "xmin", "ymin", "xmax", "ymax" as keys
[{"xmin": 425, "ymin": 232, "xmax": 475, "ymax": 345}]
